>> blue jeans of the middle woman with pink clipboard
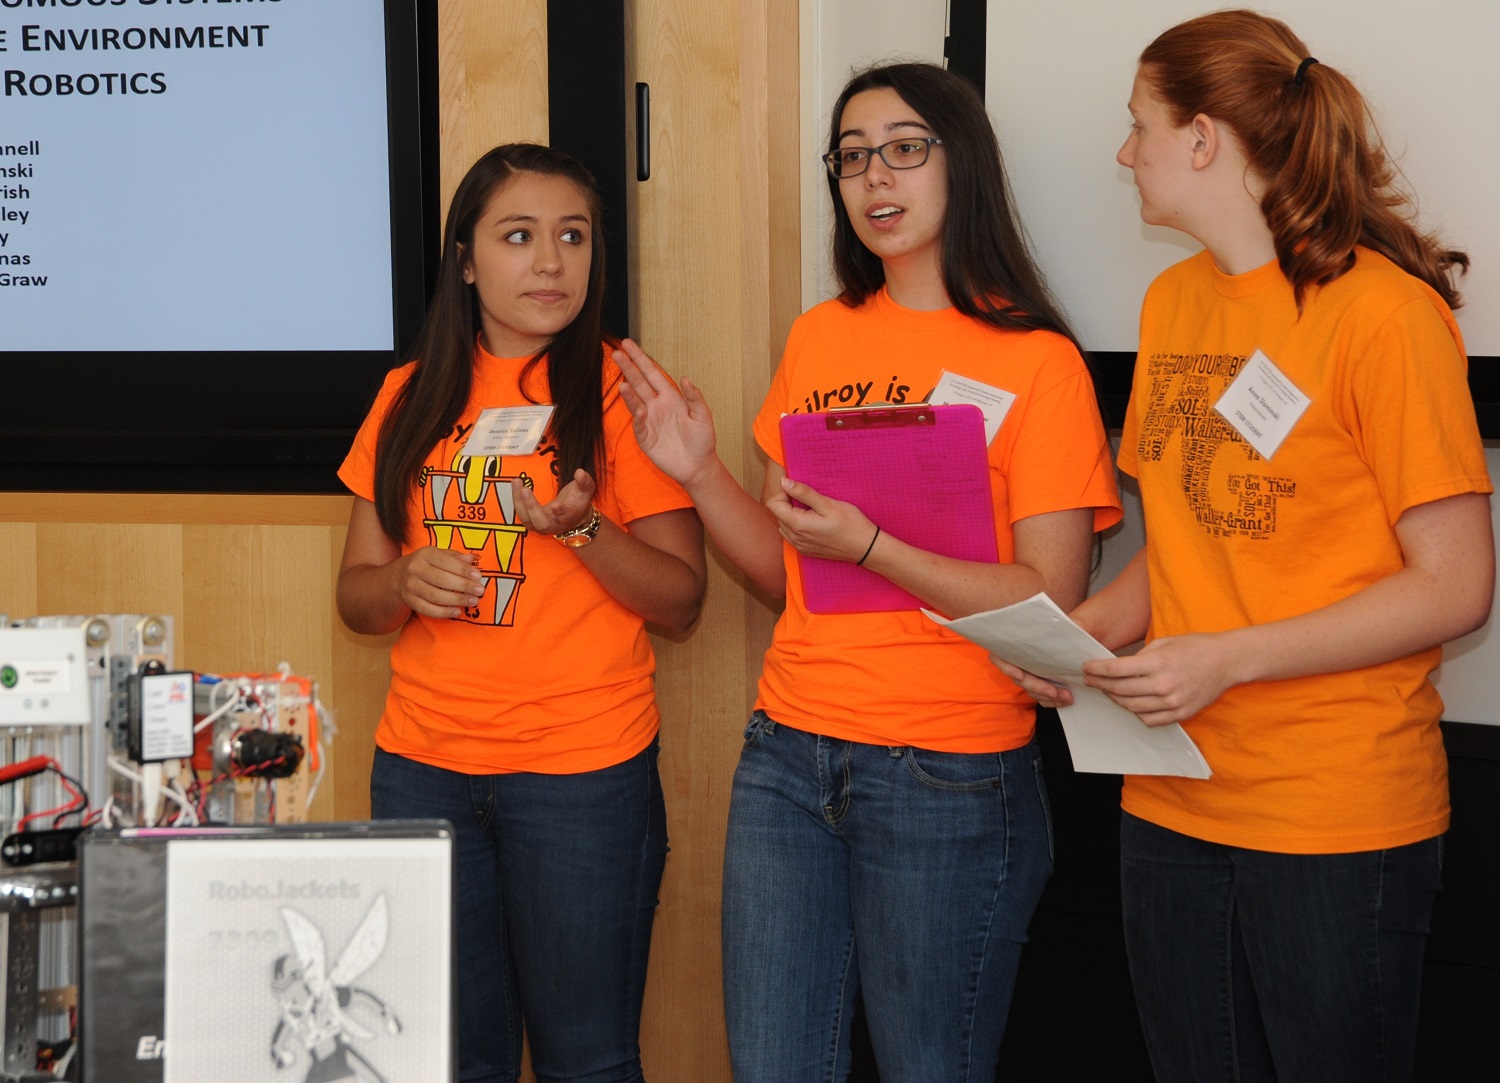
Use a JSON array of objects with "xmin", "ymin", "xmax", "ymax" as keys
[{"xmin": 723, "ymin": 711, "xmax": 1052, "ymax": 1083}]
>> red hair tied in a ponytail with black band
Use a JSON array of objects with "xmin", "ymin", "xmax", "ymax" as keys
[{"xmin": 1140, "ymin": 11, "xmax": 1469, "ymax": 309}]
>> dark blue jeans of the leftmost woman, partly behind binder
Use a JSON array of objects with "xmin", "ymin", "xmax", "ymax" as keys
[{"xmin": 371, "ymin": 743, "xmax": 668, "ymax": 1083}]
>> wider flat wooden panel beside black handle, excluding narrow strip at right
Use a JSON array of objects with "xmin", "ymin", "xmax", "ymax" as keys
[{"xmin": 632, "ymin": 10, "xmax": 765, "ymax": 1062}]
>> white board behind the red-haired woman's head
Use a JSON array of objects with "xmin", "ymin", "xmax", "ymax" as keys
[{"xmin": 986, "ymin": 0, "xmax": 1500, "ymax": 356}]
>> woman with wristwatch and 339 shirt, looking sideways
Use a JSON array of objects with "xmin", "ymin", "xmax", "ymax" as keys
[{"xmin": 338, "ymin": 144, "xmax": 705, "ymax": 1083}]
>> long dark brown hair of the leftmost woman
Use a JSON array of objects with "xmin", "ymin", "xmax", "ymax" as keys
[{"xmin": 375, "ymin": 143, "xmax": 606, "ymax": 542}]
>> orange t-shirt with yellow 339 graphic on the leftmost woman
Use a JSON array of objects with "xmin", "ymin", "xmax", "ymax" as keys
[{"xmin": 339, "ymin": 348, "xmax": 692, "ymax": 774}]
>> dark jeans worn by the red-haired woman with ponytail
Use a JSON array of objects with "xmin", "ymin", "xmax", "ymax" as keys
[{"xmin": 1121, "ymin": 813, "xmax": 1443, "ymax": 1083}]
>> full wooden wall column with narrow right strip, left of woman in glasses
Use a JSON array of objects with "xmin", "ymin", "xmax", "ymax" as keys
[{"xmin": 627, "ymin": 0, "xmax": 801, "ymax": 1080}]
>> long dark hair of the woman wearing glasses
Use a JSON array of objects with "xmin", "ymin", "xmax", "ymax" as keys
[{"xmin": 828, "ymin": 63, "xmax": 1082, "ymax": 353}]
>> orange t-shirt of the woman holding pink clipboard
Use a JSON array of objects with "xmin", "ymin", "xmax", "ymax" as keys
[{"xmin": 755, "ymin": 290, "xmax": 1121, "ymax": 752}]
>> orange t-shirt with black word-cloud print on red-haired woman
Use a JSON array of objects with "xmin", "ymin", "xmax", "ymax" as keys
[{"xmin": 1119, "ymin": 249, "xmax": 1491, "ymax": 854}]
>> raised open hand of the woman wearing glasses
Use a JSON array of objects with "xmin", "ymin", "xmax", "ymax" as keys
[{"xmin": 614, "ymin": 339, "xmax": 717, "ymax": 491}]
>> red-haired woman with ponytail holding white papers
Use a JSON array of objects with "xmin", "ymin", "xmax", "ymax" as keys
[{"xmin": 1007, "ymin": 11, "xmax": 1494, "ymax": 1083}]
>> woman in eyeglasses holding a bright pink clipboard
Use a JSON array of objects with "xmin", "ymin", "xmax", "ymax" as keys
[{"xmin": 621, "ymin": 65, "xmax": 1119, "ymax": 1083}]
